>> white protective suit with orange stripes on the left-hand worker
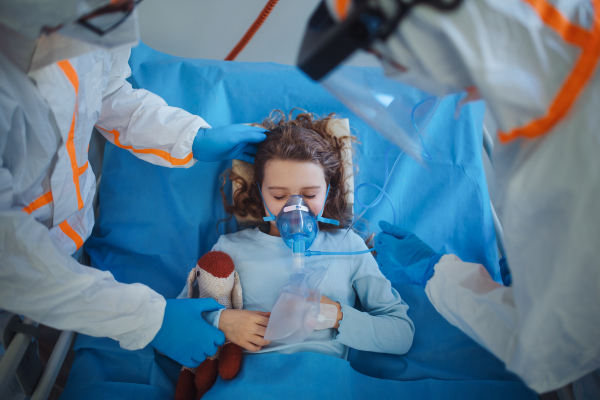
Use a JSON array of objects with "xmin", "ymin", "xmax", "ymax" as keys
[{"xmin": 0, "ymin": 0, "xmax": 209, "ymax": 350}]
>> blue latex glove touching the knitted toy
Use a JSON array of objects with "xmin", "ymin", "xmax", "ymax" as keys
[{"xmin": 150, "ymin": 299, "xmax": 225, "ymax": 368}]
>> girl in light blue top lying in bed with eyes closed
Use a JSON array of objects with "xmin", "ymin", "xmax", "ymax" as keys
[{"xmin": 205, "ymin": 112, "xmax": 414, "ymax": 359}]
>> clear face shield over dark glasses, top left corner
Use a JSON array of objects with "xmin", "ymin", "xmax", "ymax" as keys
[{"xmin": 0, "ymin": 0, "xmax": 139, "ymax": 72}]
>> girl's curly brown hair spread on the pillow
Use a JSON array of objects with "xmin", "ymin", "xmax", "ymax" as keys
[{"xmin": 221, "ymin": 109, "xmax": 356, "ymax": 231}]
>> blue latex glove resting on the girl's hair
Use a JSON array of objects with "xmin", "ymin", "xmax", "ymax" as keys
[{"xmin": 192, "ymin": 124, "xmax": 267, "ymax": 164}]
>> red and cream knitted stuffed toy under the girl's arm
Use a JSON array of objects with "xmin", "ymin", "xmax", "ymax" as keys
[{"xmin": 175, "ymin": 251, "xmax": 243, "ymax": 400}]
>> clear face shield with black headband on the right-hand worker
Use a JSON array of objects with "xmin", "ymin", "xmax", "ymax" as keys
[{"xmin": 298, "ymin": 0, "xmax": 461, "ymax": 161}]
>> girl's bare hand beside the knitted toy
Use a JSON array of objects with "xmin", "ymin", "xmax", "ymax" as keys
[{"xmin": 219, "ymin": 310, "xmax": 271, "ymax": 351}]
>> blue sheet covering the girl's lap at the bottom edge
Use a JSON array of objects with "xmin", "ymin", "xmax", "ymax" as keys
[{"xmin": 202, "ymin": 353, "xmax": 536, "ymax": 400}]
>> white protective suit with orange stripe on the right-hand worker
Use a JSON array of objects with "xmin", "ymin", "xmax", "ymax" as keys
[{"xmin": 329, "ymin": 0, "xmax": 600, "ymax": 393}]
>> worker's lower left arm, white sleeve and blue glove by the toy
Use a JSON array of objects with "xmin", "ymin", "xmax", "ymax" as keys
[{"xmin": 0, "ymin": 211, "xmax": 225, "ymax": 367}]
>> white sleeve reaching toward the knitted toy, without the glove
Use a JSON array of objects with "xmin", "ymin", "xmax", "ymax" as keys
[{"xmin": 0, "ymin": 208, "xmax": 166, "ymax": 350}]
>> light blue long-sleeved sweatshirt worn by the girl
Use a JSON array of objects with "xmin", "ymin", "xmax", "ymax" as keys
[{"xmin": 185, "ymin": 229, "xmax": 415, "ymax": 359}]
